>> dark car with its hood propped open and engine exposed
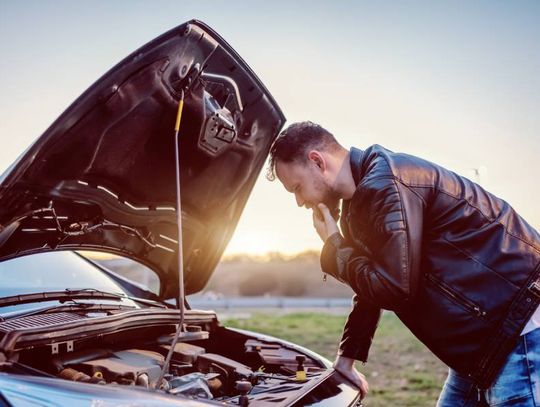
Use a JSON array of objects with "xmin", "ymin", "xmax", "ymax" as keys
[{"xmin": 0, "ymin": 20, "xmax": 360, "ymax": 406}]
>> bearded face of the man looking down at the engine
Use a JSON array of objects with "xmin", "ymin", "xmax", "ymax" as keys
[{"xmin": 276, "ymin": 160, "xmax": 339, "ymax": 210}]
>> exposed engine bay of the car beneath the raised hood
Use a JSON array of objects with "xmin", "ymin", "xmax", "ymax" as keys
[{"xmin": 0, "ymin": 312, "xmax": 329, "ymax": 406}]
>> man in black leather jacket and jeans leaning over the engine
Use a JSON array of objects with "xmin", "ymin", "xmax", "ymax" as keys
[{"xmin": 268, "ymin": 122, "xmax": 540, "ymax": 407}]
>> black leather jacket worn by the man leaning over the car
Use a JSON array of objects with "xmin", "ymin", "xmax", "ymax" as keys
[{"xmin": 321, "ymin": 145, "xmax": 540, "ymax": 388}]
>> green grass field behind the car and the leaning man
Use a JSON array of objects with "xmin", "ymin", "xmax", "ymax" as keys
[{"xmin": 222, "ymin": 313, "xmax": 447, "ymax": 407}]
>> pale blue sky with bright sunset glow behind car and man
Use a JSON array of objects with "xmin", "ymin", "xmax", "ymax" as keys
[{"xmin": 0, "ymin": 0, "xmax": 540, "ymax": 254}]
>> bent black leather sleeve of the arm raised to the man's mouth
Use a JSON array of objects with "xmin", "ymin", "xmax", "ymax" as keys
[{"xmin": 321, "ymin": 176, "xmax": 424, "ymax": 310}]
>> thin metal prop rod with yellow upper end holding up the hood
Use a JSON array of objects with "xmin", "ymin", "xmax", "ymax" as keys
[{"xmin": 156, "ymin": 90, "xmax": 185, "ymax": 388}]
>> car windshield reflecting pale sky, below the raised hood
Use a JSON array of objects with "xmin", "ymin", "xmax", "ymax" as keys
[{"xmin": 0, "ymin": 251, "xmax": 131, "ymax": 313}]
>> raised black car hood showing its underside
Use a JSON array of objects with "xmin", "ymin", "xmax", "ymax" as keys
[{"xmin": 0, "ymin": 21, "xmax": 285, "ymax": 299}]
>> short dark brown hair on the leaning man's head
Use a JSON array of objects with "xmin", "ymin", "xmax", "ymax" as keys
[{"xmin": 266, "ymin": 121, "xmax": 339, "ymax": 181}]
